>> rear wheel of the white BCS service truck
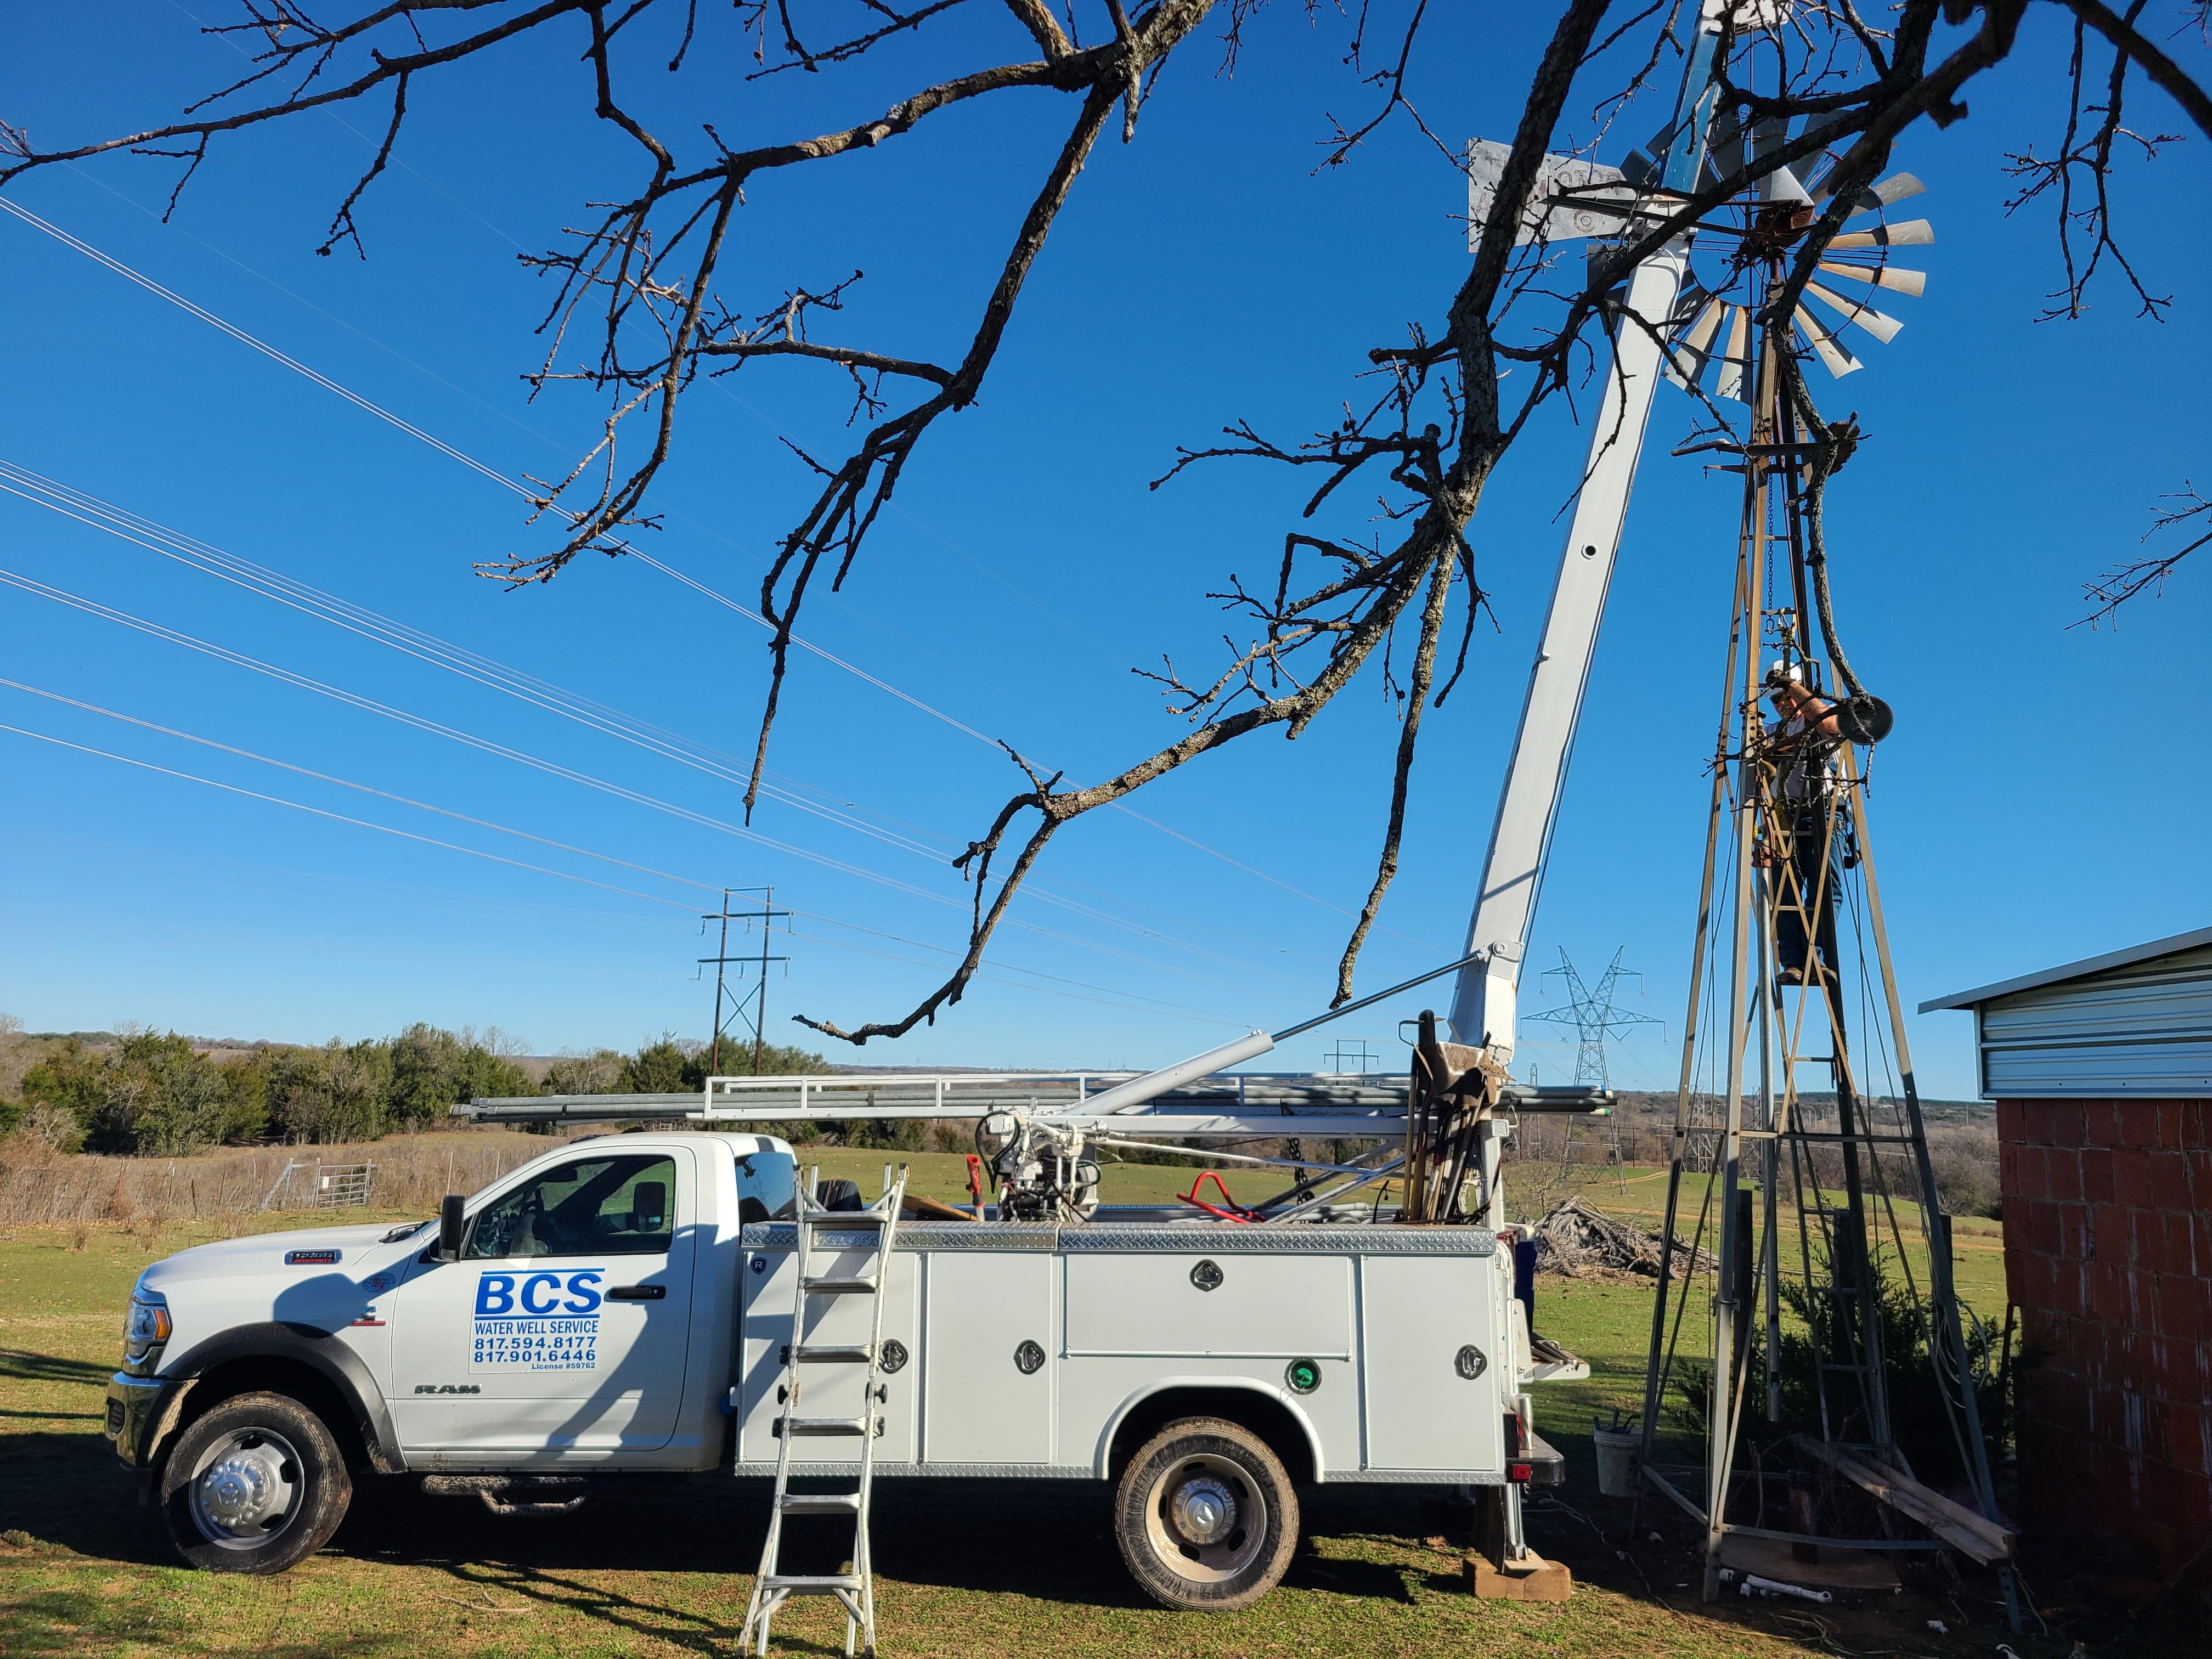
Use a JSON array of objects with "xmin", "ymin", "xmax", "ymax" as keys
[{"xmin": 1113, "ymin": 1418, "xmax": 1299, "ymax": 1612}]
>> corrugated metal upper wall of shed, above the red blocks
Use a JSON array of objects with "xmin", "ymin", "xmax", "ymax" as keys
[{"xmin": 1976, "ymin": 947, "xmax": 2212, "ymax": 1099}]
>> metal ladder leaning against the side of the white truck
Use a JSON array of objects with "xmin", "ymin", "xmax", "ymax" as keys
[{"xmin": 737, "ymin": 1164, "xmax": 907, "ymax": 1659}]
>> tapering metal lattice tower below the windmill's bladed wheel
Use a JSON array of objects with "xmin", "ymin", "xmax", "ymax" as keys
[{"xmin": 1644, "ymin": 280, "xmax": 2017, "ymax": 1617}]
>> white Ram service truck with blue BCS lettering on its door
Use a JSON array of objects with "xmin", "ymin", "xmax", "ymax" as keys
[{"xmin": 106, "ymin": 1132, "xmax": 1584, "ymax": 1608}]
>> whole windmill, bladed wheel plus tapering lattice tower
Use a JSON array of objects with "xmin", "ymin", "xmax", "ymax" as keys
[{"xmin": 1623, "ymin": 114, "xmax": 2017, "ymax": 1628}]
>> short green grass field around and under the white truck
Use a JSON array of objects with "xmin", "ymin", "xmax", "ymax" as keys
[{"xmin": 0, "ymin": 1177, "xmax": 2106, "ymax": 1659}]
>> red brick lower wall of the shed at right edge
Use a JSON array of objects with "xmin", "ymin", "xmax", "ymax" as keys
[{"xmin": 1997, "ymin": 1099, "xmax": 2212, "ymax": 1573}]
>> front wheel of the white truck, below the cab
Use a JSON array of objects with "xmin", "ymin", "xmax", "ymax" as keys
[{"xmin": 159, "ymin": 1393, "xmax": 354, "ymax": 1573}]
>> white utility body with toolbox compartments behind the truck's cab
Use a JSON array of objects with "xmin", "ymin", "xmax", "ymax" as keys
[{"xmin": 737, "ymin": 1207, "xmax": 1553, "ymax": 1487}]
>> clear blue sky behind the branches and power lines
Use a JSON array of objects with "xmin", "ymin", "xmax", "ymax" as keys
[{"xmin": 0, "ymin": 4, "xmax": 2212, "ymax": 1095}]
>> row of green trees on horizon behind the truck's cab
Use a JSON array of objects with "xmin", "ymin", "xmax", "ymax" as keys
[{"xmin": 0, "ymin": 1022, "xmax": 827, "ymax": 1157}]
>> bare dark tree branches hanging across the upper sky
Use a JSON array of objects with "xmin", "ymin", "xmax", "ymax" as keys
[{"xmin": 0, "ymin": 0, "xmax": 2212, "ymax": 1042}]
